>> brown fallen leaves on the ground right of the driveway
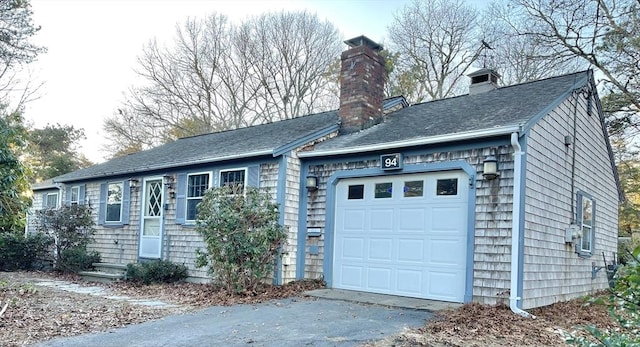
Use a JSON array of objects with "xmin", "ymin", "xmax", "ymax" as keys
[{"xmin": 382, "ymin": 299, "xmax": 615, "ymax": 347}]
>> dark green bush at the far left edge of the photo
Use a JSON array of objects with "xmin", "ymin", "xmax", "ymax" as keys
[{"xmin": 0, "ymin": 233, "xmax": 53, "ymax": 271}]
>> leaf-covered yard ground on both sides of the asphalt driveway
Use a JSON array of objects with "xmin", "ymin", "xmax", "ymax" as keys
[{"xmin": 0, "ymin": 272, "xmax": 615, "ymax": 347}]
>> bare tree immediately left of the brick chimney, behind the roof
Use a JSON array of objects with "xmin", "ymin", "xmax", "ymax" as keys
[{"xmin": 237, "ymin": 12, "xmax": 342, "ymax": 122}]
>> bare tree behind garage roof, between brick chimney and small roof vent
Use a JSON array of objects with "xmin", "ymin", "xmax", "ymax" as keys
[{"xmin": 389, "ymin": 0, "xmax": 480, "ymax": 102}]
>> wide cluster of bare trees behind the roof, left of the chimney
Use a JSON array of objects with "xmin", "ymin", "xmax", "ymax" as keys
[{"xmin": 104, "ymin": 12, "xmax": 341, "ymax": 155}]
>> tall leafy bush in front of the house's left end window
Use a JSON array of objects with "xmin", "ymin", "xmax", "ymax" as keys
[{"xmin": 36, "ymin": 205, "xmax": 96, "ymax": 272}]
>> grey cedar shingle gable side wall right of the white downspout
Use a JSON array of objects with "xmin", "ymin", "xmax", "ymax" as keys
[{"xmin": 523, "ymin": 96, "xmax": 618, "ymax": 308}]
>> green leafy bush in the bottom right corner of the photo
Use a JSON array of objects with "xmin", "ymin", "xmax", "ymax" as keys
[{"xmin": 569, "ymin": 247, "xmax": 640, "ymax": 347}]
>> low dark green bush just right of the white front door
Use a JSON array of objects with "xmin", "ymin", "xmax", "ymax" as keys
[{"xmin": 125, "ymin": 260, "xmax": 189, "ymax": 284}]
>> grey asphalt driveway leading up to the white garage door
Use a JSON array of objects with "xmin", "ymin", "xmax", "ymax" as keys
[{"xmin": 36, "ymin": 298, "xmax": 433, "ymax": 347}]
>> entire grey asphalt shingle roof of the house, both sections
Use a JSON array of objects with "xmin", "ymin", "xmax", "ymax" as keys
[{"xmin": 54, "ymin": 71, "xmax": 588, "ymax": 182}]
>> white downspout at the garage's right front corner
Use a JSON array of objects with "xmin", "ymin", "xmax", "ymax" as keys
[{"xmin": 509, "ymin": 133, "xmax": 536, "ymax": 318}]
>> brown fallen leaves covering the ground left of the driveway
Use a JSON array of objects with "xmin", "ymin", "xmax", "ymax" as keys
[{"xmin": 0, "ymin": 272, "xmax": 323, "ymax": 347}]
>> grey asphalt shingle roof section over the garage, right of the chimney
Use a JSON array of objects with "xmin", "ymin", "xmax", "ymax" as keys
[{"xmin": 311, "ymin": 71, "xmax": 588, "ymax": 153}]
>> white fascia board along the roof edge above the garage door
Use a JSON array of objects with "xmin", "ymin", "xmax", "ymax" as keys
[{"xmin": 298, "ymin": 125, "xmax": 520, "ymax": 158}]
